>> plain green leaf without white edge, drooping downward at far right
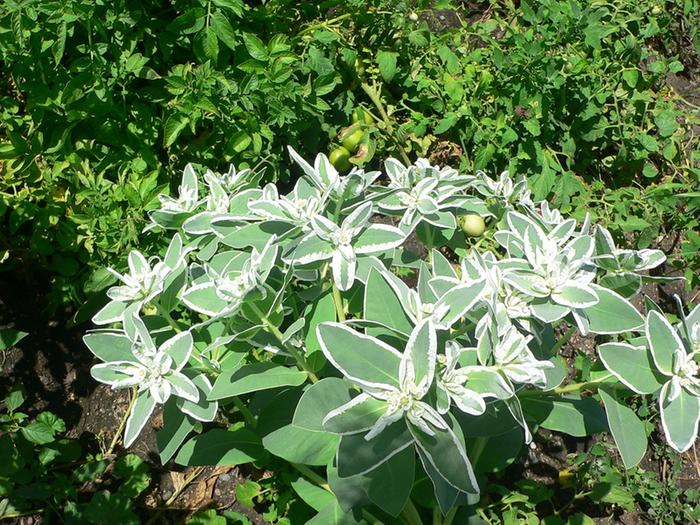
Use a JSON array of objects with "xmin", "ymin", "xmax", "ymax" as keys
[{"xmin": 598, "ymin": 386, "xmax": 647, "ymax": 469}]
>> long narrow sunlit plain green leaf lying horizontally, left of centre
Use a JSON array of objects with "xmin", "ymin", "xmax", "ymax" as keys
[{"xmin": 208, "ymin": 362, "xmax": 306, "ymax": 400}]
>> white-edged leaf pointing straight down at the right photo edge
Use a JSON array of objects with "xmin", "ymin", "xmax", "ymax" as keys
[{"xmin": 659, "ymin": 381, "xmax": 700, "ymax": 452}]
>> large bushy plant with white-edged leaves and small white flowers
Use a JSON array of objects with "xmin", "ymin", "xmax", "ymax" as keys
[{"xmin": 85, "ymin": 150, "xmax": 700, "ymax": 525}]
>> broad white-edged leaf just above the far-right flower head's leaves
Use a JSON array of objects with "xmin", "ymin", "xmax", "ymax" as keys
[{"xmin": 584, "ymin": 284, "xmax": 644, "ymax": 334}]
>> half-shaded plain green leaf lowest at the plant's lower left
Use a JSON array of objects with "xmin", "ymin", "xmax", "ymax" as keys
[{"xmin": 175, "ymin": 429, "xmax": 265, "ymax": 467}]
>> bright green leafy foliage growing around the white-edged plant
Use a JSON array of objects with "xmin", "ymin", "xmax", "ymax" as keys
[{"xmin": 0, "ymin": 0, "xmax": 700, "ymax": 523}]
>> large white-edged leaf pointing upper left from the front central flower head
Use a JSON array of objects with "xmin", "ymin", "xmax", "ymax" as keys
[{"xmin": 316, "ymin": 323, "xmax": 401, "ymax": 387}]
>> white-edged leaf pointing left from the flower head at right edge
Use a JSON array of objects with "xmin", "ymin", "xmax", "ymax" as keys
[{"xmin": 598, "ymin": 343, "xmax": 664, "ymax": 394}]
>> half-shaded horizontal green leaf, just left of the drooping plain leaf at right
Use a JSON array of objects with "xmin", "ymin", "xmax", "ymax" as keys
[{"xmin": 521, "ymin": 397, "xmax": 608, "ymax": 437}]
